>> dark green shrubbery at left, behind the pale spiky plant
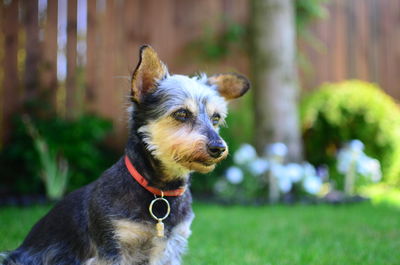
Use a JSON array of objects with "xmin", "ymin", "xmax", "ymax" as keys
[{"xmin": 0, "ymin": 112, "xmax": 114, "ymax": 193}]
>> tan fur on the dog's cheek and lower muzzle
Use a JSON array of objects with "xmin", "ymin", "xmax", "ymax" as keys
[{"xmin": 139, "ymin": 116, "xmax": 228, "ymax": 180}]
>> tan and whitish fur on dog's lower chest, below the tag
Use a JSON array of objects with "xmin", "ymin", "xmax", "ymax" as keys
[{"xmin": 114, "ymin": 214, "xmax": 193, "ymax": 265}]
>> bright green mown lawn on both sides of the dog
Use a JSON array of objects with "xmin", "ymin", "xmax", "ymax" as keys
[{"xmin": 0, "ymin": 203, "xmax": 400, "ymax": 265}]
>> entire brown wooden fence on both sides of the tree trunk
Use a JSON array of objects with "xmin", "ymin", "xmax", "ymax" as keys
[{"xmin": 0, "ymin": 0, "xmax": 400, "ymax": 146}]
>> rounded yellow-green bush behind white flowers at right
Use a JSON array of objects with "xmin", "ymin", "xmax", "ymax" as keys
[{"xmin": 301, "ymin": 80, "xmax": 400, "ymax": 189}]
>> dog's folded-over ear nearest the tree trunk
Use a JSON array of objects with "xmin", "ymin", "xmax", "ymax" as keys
[{"xmin": 208, "ymin": 73, "xmax": 250, "ymax": 100}]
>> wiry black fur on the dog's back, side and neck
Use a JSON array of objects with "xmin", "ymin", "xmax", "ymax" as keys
[{"xmin": 4, "ymin": 95, "xmax": 192, "ymax": 265}]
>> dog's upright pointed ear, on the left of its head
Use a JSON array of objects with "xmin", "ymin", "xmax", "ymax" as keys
[{"xmin": 131, "ymin": 45, "xmax": 168, "ymax": 103}]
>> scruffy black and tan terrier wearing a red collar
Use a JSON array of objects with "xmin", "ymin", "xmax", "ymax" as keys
[{"xmin": 3, "ymin": 46, "xmax": 249, "ymax": 265}]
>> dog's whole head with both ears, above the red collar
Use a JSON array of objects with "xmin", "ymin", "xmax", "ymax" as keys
[{"xmin": 132, "ymin": 46, "xmax": 249, "ymax": 180}]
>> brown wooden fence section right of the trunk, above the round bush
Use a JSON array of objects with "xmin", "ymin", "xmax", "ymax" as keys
[{"xmin": 301, "ymin": 0, "xmax": 400, "ymax": 100}]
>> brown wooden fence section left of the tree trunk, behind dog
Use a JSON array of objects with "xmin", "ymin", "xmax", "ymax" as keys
[{"xmin": 0, "ymin": 0, "xmax": 248, "ymax": 146}]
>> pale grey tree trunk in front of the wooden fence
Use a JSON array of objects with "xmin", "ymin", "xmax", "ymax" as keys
[{"xmin": 251, "ymin": 0, "xmax": 302, "ymax": 162}]
